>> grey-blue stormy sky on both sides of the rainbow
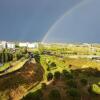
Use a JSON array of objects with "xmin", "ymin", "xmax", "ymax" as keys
[{"xmin": 0, "ymin": 0, "xmax": 100, "ymax": 42}]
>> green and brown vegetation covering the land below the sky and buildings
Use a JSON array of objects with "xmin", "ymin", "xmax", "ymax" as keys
[{"xmin": 0, "ymin": 43, "xmax": 100, "ymax": 100}]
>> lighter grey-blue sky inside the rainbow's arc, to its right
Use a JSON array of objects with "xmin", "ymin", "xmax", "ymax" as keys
[{"xmin": 43, "ymin": 0, "xmax": 100, "ymax": 43}]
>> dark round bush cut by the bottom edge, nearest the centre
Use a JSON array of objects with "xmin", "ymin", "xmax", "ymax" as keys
[{"xmin": 49, "ymin": 90, "xmax": 61, "ymax": 100}]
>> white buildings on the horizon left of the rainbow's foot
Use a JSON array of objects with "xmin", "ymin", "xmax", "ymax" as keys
[{"xmin": 0, "ymin": 41, "xmax": 38, "ymax": 49}]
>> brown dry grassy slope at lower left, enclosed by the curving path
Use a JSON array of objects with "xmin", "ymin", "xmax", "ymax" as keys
[{"xmin": 0, "ymin": 60, "xmax": 43, "ymax": 100}]
